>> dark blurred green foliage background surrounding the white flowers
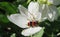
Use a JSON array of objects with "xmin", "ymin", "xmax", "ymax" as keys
[{"xmin": 0, "ymin": 0, "xmax": 60, "ymax": 37}]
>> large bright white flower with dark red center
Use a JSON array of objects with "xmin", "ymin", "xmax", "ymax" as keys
[{"xmin": 7, "ymin": 2, "xmax": 42, "ymax": 36}]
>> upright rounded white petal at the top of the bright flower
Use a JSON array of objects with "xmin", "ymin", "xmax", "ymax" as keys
[{"xmin": 28, "ymin": 2, "xmax": 39, "ymax": 13}]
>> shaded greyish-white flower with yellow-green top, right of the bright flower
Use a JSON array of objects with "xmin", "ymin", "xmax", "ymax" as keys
[{"xmin": 37, "ymin": 0, "xmax": 58, "ymax": 21}]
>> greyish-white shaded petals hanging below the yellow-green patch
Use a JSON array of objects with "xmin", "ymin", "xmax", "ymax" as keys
[{"xmin": 42, "ymin": 4, "xmax": 58, "ymax": 21}]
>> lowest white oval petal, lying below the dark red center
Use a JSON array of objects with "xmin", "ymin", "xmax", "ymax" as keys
[{"xmin": 21, "ymin": 27, "xmax": 42, "ymax": 36}]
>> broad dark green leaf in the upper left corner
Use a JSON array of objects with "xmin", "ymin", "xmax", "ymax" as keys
[{"xmin": 0, "ymin": 2, "xmax": 17, "ymax": 13}]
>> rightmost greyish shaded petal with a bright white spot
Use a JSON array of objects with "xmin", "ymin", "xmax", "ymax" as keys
[{"xmin": 47, "ymin": 6, "xmax": 58, "ymax": 21}]
